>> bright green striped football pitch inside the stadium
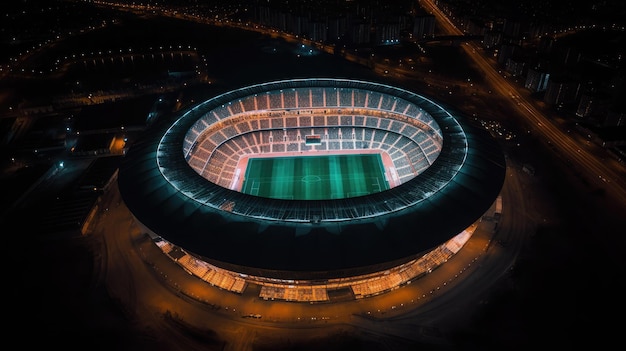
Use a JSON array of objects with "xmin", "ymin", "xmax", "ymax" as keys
[{"xmin": 241, "ymin": 154, "xmax": 389, "ymax": 200}]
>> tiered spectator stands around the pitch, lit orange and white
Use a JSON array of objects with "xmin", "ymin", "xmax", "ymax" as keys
[{"xmin": 180, "ymin": 88, "xmax": 441, "ymax": 188}]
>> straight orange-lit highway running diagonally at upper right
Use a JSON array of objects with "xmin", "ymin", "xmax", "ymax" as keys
[{"xmin": 419, "ymin": 0, "xmax": 626, "ymax": 209}]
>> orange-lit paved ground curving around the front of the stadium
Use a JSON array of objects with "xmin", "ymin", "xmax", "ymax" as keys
[{"xmin": 81, "ymin": 161, "xmax": 541, "ymax": 351}]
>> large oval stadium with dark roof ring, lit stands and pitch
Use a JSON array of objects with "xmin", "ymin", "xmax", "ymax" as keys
[{"xmin": 118, "ymin": 78, "xmax": 505, "ymax": 302}]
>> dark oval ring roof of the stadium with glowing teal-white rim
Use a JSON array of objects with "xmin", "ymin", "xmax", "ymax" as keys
[{"xmin": 118, "ymin": 79, "xmax": 505, "ymax": 279}]
